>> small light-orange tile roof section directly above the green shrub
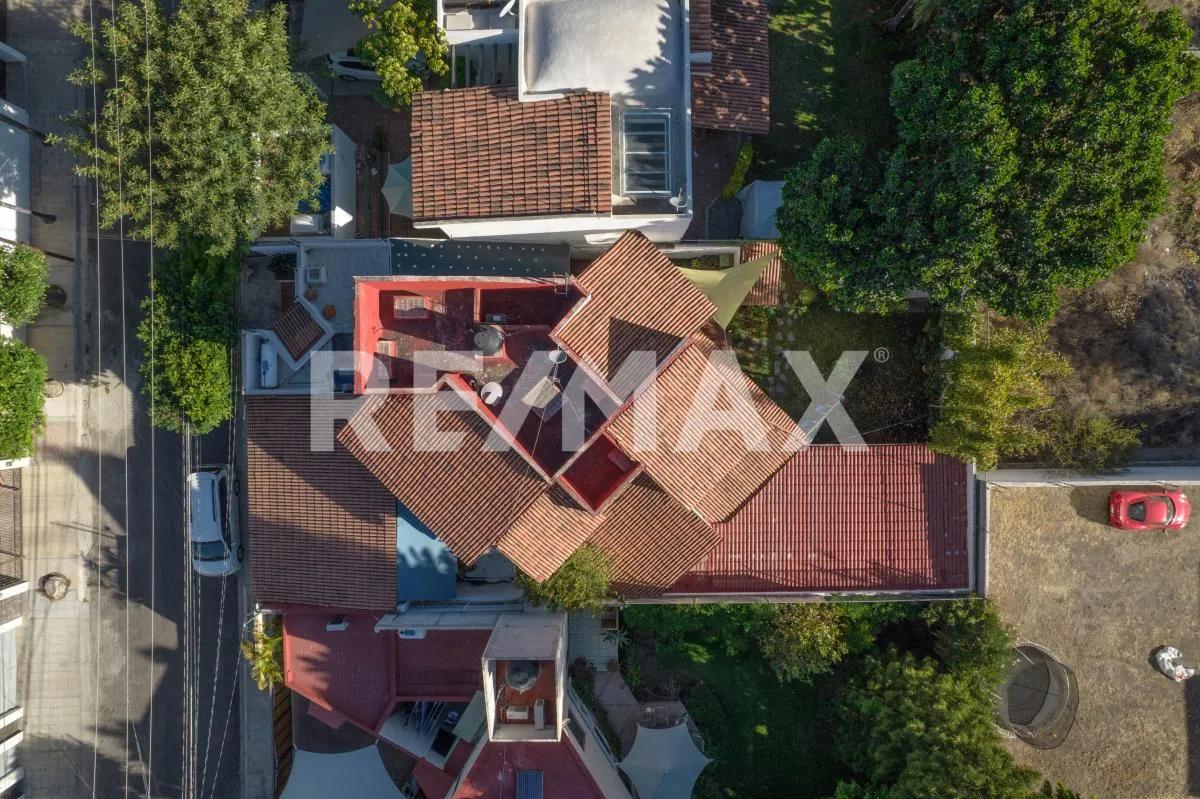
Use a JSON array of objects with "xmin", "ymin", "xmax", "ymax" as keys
[{"xmin": 496, "ymin": 486, "xmax": 604, "ymax": 582}]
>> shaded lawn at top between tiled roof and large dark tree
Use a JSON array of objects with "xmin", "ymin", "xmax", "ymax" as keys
[{"xmin": 750, "ymin": 0, "xmax": 907, "ymax": 180}]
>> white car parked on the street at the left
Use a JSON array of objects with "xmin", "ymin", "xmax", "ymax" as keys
[{"xmin": 187, "ymin": 465, "xmax": 245, "ymax": 577}]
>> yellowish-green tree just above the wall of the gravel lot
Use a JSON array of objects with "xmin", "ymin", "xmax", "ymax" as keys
[{"xmin": 930, "ymin": 318, "xmax": 1070, "ymax": 469}]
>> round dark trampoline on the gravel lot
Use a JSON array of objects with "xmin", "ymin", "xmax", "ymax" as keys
[{"xmin": 996, "ymin": 643, "xmax": 1079, "ymax": 749}]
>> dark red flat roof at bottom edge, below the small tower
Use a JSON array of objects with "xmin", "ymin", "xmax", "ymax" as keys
[{"xmin": 454, "ymin": 737, "xmax": 604, "ymax": 799}]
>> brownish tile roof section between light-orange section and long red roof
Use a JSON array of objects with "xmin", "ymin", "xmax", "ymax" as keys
[{"xmin": 590, "ymin": 475, "xmax": 720, "ymax": 596}]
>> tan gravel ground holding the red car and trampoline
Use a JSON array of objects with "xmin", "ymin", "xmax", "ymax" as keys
[{"xmin": 988, "ymin": 486, "xmax": 1200, "ymax": 798}]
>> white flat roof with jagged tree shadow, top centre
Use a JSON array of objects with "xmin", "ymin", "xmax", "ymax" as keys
[{"xmin": 521, "ymin": 0, "xmax": 684, "ymax": 108}]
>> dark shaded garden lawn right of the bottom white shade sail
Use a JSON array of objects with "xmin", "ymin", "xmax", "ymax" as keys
[{"xmin": 662, "ymin": 645, "xmax": 845, "ymax": 799}]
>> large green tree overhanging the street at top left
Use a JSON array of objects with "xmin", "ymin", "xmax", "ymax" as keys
[{"xmin": 64, "ymin": 0, "xmax": 329, "ymax": 253}]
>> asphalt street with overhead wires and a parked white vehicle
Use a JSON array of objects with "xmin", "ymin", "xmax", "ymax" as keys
[{"xmin": 85, "ymin": 236, "xmax": 241, "ymax": 797}]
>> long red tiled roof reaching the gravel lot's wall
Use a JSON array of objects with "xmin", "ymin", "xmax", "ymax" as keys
[{"xmin": 671, "ymin": 444, "xmax": 968, "ymax": 594}]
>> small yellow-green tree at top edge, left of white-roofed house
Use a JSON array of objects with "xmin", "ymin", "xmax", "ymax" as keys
[{"xmin": 349, "ymin": 0, "xmax": 450, "ymax": 107}]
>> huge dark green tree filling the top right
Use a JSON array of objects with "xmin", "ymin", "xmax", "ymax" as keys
[{"xmin": 780, "ymin": 0, "xmax": 1200, "ymax": 319}]
